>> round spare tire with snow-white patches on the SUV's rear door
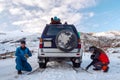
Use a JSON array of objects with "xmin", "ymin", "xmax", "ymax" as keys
[{"xmin": 55, "ymin": 30, "xmax": 77, "ymax": 52}]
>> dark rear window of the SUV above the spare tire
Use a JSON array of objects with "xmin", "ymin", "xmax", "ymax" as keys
[{"xmin": 46, "ymin": 25, "xmax": 74, "ymax": 35}]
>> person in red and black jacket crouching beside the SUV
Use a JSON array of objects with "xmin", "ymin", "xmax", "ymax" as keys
[{"xmin": 86, "ymin": 46, "xmax": 109, "ymax": 72}]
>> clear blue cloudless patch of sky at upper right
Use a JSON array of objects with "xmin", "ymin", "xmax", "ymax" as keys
[{"xmin": 82, "ymin": 0, "xmax": 120, "ymax": 32}]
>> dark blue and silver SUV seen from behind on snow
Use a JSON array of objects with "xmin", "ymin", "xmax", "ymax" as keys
[{"xmin": 38, "ymin": 24, "xmax": 82, "ymax": 68}]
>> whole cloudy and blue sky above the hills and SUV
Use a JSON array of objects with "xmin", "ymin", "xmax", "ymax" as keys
[{"xmin": 0, "ymin": 0, "xmax": 120, "ymax": 33}]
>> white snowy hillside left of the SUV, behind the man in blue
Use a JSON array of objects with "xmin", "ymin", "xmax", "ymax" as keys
[{"xmin": 0, "ymin": 31, "xmax": 40, "ymax": 54}]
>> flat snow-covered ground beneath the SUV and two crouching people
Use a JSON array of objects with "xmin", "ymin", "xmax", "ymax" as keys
[{"xmin": 0, "ymin": 47, "xmax": 120, "ymax": 80}]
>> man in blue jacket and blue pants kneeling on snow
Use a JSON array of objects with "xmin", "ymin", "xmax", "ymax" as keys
[{"xmin": 15, "ymin": 41, "xmax": 32, "ymax": 74}]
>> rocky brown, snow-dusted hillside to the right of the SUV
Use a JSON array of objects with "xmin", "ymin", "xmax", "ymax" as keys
[{"xmin": 81, "ymin": 31, "xmax": 120, "ymax": 47}]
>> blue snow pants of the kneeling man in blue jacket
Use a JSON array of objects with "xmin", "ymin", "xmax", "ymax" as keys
[{"xmin": 15, "ymin": 57, "xmax": 32, "ymax": 71}]
